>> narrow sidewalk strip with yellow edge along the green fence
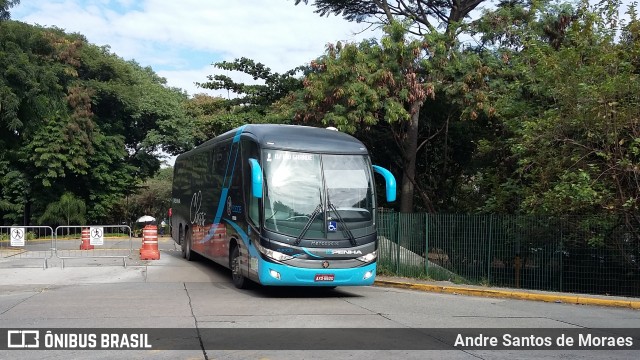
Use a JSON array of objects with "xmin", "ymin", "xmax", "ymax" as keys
[{"xmin": 375, "ymin": 276, "xmax": 640, "ymax": 309}]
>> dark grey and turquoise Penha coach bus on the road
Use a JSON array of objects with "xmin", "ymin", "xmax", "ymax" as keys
[{"xmin": 171, "ymin": 124, "xmax": 396, "ymax": 288}]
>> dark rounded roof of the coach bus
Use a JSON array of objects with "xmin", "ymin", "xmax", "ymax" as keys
[{"xmin": 185, "ymin": 124, "xmax": 367, "ymax": 154}]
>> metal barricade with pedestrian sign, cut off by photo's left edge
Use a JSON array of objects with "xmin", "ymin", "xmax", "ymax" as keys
[{"xmin": 0, "ymin": 226, "xmax": 55, "ymax": 269}]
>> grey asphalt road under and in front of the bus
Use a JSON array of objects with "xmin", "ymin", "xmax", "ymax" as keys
[{"xmin": 0, "ymin": 239, "xmax": 640, "ymax": 359}]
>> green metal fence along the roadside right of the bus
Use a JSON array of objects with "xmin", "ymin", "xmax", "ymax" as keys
[{"xmin": 378, "ymin": 212, "xmax": 640, "ymax": 297}]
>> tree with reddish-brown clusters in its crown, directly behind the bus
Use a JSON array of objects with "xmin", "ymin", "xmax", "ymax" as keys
[{"xmin": 292, "ymin": 23, "xmax": 495, "ymax": 212}]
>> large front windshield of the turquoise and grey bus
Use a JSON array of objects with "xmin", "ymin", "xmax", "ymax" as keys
[{"xmin": 262, "ymin": 150, "xmax": 375, "ymax": 240}]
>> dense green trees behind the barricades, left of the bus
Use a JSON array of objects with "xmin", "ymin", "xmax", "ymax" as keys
[{"xmin": 0, "ymin": 21, "xmax": 193, "ymax": 224}]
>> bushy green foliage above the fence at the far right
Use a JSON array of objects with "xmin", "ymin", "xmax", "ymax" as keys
[{"xmin": 470, "ymin": 2, "xmax": 640, "ymax": 226}]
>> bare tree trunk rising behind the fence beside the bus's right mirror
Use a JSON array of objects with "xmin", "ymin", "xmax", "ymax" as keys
[{"xmin": 400, "ymin": 101, "xmax": 422, "ymax": 213}]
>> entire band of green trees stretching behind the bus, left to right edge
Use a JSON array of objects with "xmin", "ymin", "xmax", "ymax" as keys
[{"xmin": 0, "ymin": 1, "xmax": 640, "ymax": 245}]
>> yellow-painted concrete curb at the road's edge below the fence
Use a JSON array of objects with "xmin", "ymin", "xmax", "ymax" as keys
[{"xmin": 374, "ymin": 280, "xmax": 640, "ymax": 309}]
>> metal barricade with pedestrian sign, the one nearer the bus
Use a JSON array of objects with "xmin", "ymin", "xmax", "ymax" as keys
[{"xmin": 55, "ymin": 225, "xmax": 133, "ymax": 268}]
